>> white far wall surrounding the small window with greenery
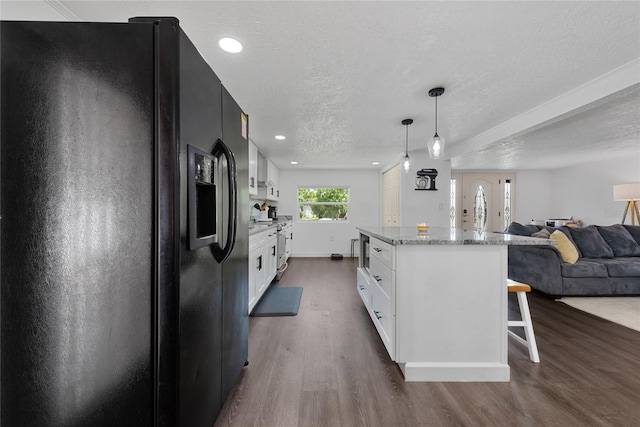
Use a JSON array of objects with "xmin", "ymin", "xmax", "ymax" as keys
[{"xmin": 277, "ymin": 169, "xmax": 380, "ymax": 257}]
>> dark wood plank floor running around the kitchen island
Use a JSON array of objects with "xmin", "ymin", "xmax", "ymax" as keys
[{"xmin": 216, "ymin": 258, "xmax": 640, "ymax": 427}]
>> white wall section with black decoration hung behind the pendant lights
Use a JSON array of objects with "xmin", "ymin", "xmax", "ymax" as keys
[{"xmin": 401, "ymin": 150, "xmax": 451, "ymax": 227}]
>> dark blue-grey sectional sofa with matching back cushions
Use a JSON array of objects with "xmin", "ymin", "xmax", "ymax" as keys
[{"xmin": 506, "ymin": 223, "xmax": 640, "ymax": 296}]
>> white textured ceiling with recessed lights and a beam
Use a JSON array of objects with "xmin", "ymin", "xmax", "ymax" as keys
[{"xmin": 0, "ymin": 0, "xmax": 640, "ymax": 170}]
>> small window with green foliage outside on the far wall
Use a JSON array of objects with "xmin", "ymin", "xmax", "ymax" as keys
[{"xmin": 298, "ymin": 188, "xmax": 349, "ymax": 221}]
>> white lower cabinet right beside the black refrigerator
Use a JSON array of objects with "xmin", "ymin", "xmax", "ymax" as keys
[{"xmin": 249, "ymin": 227, "xmax": 278, "ymax": 313}]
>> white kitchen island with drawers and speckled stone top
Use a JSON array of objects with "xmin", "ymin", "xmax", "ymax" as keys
[{"xmin": 357, "ymin": 227, "xmax": 553, "ymax": 381}]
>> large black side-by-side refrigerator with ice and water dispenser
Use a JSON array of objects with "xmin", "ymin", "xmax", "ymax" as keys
[{"xmin": 0, "ymin": 18, "xmax": 249, "ymax": 427}]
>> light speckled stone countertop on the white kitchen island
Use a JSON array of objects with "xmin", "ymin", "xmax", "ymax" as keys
[{"xmin": 356, "ymin": 227, "xmax": 556, "ymax": 246}]
